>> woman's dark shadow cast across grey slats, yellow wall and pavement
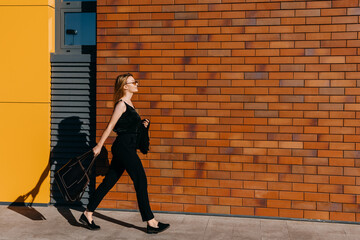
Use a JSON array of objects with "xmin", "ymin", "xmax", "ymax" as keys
[{"xmin": 8, "ymin": 117, "xmax": 109, "ymax": 221}]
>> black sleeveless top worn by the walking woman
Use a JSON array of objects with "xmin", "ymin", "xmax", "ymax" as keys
[{"xmin": 113, "ymin": 100, "xmax": 141, "ymax": 135}]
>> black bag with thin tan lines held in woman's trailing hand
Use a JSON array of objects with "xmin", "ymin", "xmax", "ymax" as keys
[{"xmin": 54, "ymin": 150, "xmax": 95, "ymax": 202}]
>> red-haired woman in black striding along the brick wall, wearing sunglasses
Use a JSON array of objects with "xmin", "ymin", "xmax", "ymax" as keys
[{"xmin": 80, "ymin": 73, "xmax": 170, "ymax": 233}]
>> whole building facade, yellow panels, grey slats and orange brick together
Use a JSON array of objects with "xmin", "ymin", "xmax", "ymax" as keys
[{"xmin": 0, "ymin": 0, "xmax": 360, "ymax": 221}]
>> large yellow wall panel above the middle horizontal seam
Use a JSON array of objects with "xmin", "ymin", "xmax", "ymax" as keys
[{"xmin": 0, "ymin": 5, "xmax": 54, "ymax": 102}]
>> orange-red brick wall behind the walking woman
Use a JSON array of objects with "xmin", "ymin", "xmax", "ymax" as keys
[{"xmin": 97, "ymin": 0, "xmax": 360, "ymax": 221}]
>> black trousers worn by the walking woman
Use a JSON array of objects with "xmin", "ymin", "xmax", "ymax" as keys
[{"xmin": 87, "ymin": 134, "xmax": 154, "ymax": 221}]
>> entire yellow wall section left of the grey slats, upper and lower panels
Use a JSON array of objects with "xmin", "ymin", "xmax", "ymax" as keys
[{"xmin": 0, "ymin": 0, "xmax": 55, "ymax": 203}]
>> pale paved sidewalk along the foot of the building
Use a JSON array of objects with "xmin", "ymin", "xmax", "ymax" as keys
[{"xmin": 0, "ymin": 206, "xmax": 360, "ymax": 240}]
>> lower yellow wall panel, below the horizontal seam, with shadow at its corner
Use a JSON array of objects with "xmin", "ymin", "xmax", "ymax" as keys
[{"xmin": 0, "ymin": 103, "xmax": 50, "ymax": 203}]
